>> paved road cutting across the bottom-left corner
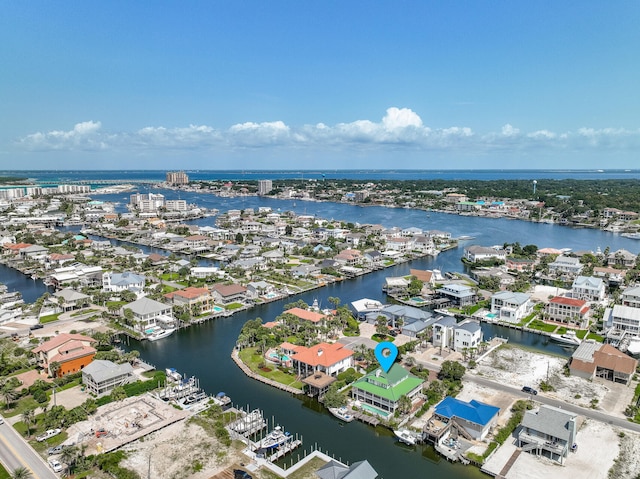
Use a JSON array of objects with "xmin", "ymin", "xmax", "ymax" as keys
[{"xmin": 0, "ymin": 422, "xmax": 58, "ymax": 479}]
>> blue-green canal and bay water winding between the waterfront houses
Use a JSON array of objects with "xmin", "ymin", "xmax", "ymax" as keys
[{"xmin": 5, "ymin": 190, "xmax": 640, "ymax": 479}]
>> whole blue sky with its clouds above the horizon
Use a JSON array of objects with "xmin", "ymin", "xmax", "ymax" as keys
[{"xmin": 0, "ymin": 0, "xmax": 640, "ymax": 169}]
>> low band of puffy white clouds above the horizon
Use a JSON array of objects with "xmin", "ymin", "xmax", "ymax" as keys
[{"xmin": 16, "ymin": 107, "xmax": 640, "ymax": 153}]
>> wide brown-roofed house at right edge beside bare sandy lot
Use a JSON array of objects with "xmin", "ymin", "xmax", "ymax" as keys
[{"xmin": 569, "ymin": 339, "xmax": 638, "ymax": 385}]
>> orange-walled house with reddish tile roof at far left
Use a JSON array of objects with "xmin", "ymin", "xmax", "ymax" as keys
[{"xmin": 32, "ymin": 333, "xmax": 96, "ymax": 377}]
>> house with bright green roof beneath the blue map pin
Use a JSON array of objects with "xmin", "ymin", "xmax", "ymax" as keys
[{"xmin": 351, "ymin": 364, "xmax": 424, "ymax": 417}]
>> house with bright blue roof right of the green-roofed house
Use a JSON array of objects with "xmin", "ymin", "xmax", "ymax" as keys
[{"xmin": 433, "ymin": 396, "xmax": 500, "ymax": 441}]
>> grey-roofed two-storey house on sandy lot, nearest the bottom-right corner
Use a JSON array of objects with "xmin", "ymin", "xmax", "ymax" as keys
[{"xmin": 518, "ymin": 405, "xmax": 578, "ymax": 464}]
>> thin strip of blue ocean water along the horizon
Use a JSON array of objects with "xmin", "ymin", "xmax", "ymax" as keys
[{"xmin": 0, "ymin": 169, "xmax": 640, "ymax": 184}]
